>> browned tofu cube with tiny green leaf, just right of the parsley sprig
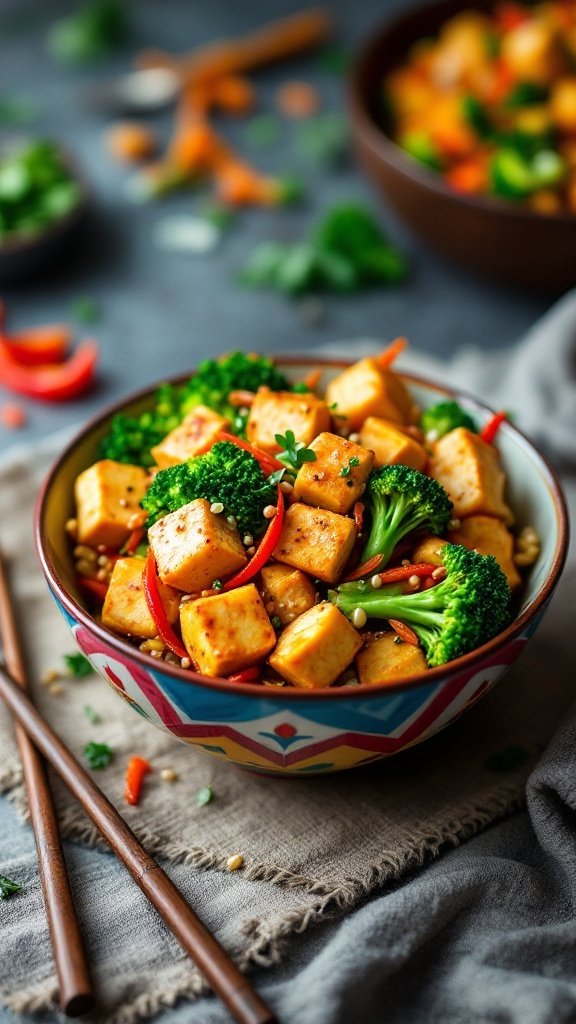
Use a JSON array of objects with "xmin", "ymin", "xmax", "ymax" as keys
[{"xmin": 294, "ymin": 433, "xmax": 374, "ymax": 515}]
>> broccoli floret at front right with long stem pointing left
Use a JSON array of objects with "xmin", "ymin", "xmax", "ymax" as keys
[{"xmin": 328, "ymin": 544, "xmax": 511, "ymax": 667}]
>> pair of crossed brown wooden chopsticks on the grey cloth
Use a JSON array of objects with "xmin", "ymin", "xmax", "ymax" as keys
[{"xmin": 0, "ymin": 558, "xmax": 276, "ymax": 1024}]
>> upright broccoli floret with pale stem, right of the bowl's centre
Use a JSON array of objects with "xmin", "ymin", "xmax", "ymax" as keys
[{"xmin": 362, "ymin": 466, "xmax": 452, "ymax": 568}]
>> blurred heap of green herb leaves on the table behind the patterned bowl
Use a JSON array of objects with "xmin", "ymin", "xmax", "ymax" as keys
[{"xmin": 241, "ymin": 203, "xmax": 407, "ymax": 295}]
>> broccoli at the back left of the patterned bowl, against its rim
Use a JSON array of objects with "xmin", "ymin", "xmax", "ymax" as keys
[{"xmin": 100, "ymin": 352, "xmax": 290, "ymax": 466}]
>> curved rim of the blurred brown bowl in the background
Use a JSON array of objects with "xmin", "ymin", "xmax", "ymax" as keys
[{"xmin": 347, "ymin": 0, "xmax": 576, "ymax": 228}]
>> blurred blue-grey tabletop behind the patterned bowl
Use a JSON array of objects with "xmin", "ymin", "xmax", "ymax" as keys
[{"xmin": 0, "ymin": 0, "xmax": 550, "ymax": 450}]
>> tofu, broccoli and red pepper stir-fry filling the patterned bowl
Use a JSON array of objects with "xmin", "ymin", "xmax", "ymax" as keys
[{"xmin": 67, "ymin": 348, "xmax": 539, "ymax": 688}]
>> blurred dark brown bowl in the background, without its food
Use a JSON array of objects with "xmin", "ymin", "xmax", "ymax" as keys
[{"xmin": 349, "ymin": 0, "xmax": 576, "ymax": 293}]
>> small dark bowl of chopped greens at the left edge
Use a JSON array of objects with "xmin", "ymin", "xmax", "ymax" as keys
[{"xmin": 0, "ymin": 139, "xmax": 87, "ymax": 283}]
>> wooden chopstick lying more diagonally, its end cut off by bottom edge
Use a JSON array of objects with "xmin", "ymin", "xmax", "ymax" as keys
[{"xmin": 0, "ymin": 655, "xmax": 277, "ymax": 1024}]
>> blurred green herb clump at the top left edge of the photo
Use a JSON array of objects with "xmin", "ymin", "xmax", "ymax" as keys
[{"xmin": 48, "ymin": 0, "xmax": 127, "ymax": 65}]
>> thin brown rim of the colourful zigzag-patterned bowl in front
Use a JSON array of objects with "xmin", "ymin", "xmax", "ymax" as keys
[{"xmin": 34, "ymin": 353, "xmax": 569, "ymax": 700}]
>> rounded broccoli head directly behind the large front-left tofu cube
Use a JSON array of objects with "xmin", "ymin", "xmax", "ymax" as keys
[{"xmin": 141, "ymin": 441, "xmax": 277, "ymax": 537}]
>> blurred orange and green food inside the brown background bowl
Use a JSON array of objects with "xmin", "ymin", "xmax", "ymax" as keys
[{"xmin": 383, "ymin": 0, "xmax": 576, "ymax": 214}]
